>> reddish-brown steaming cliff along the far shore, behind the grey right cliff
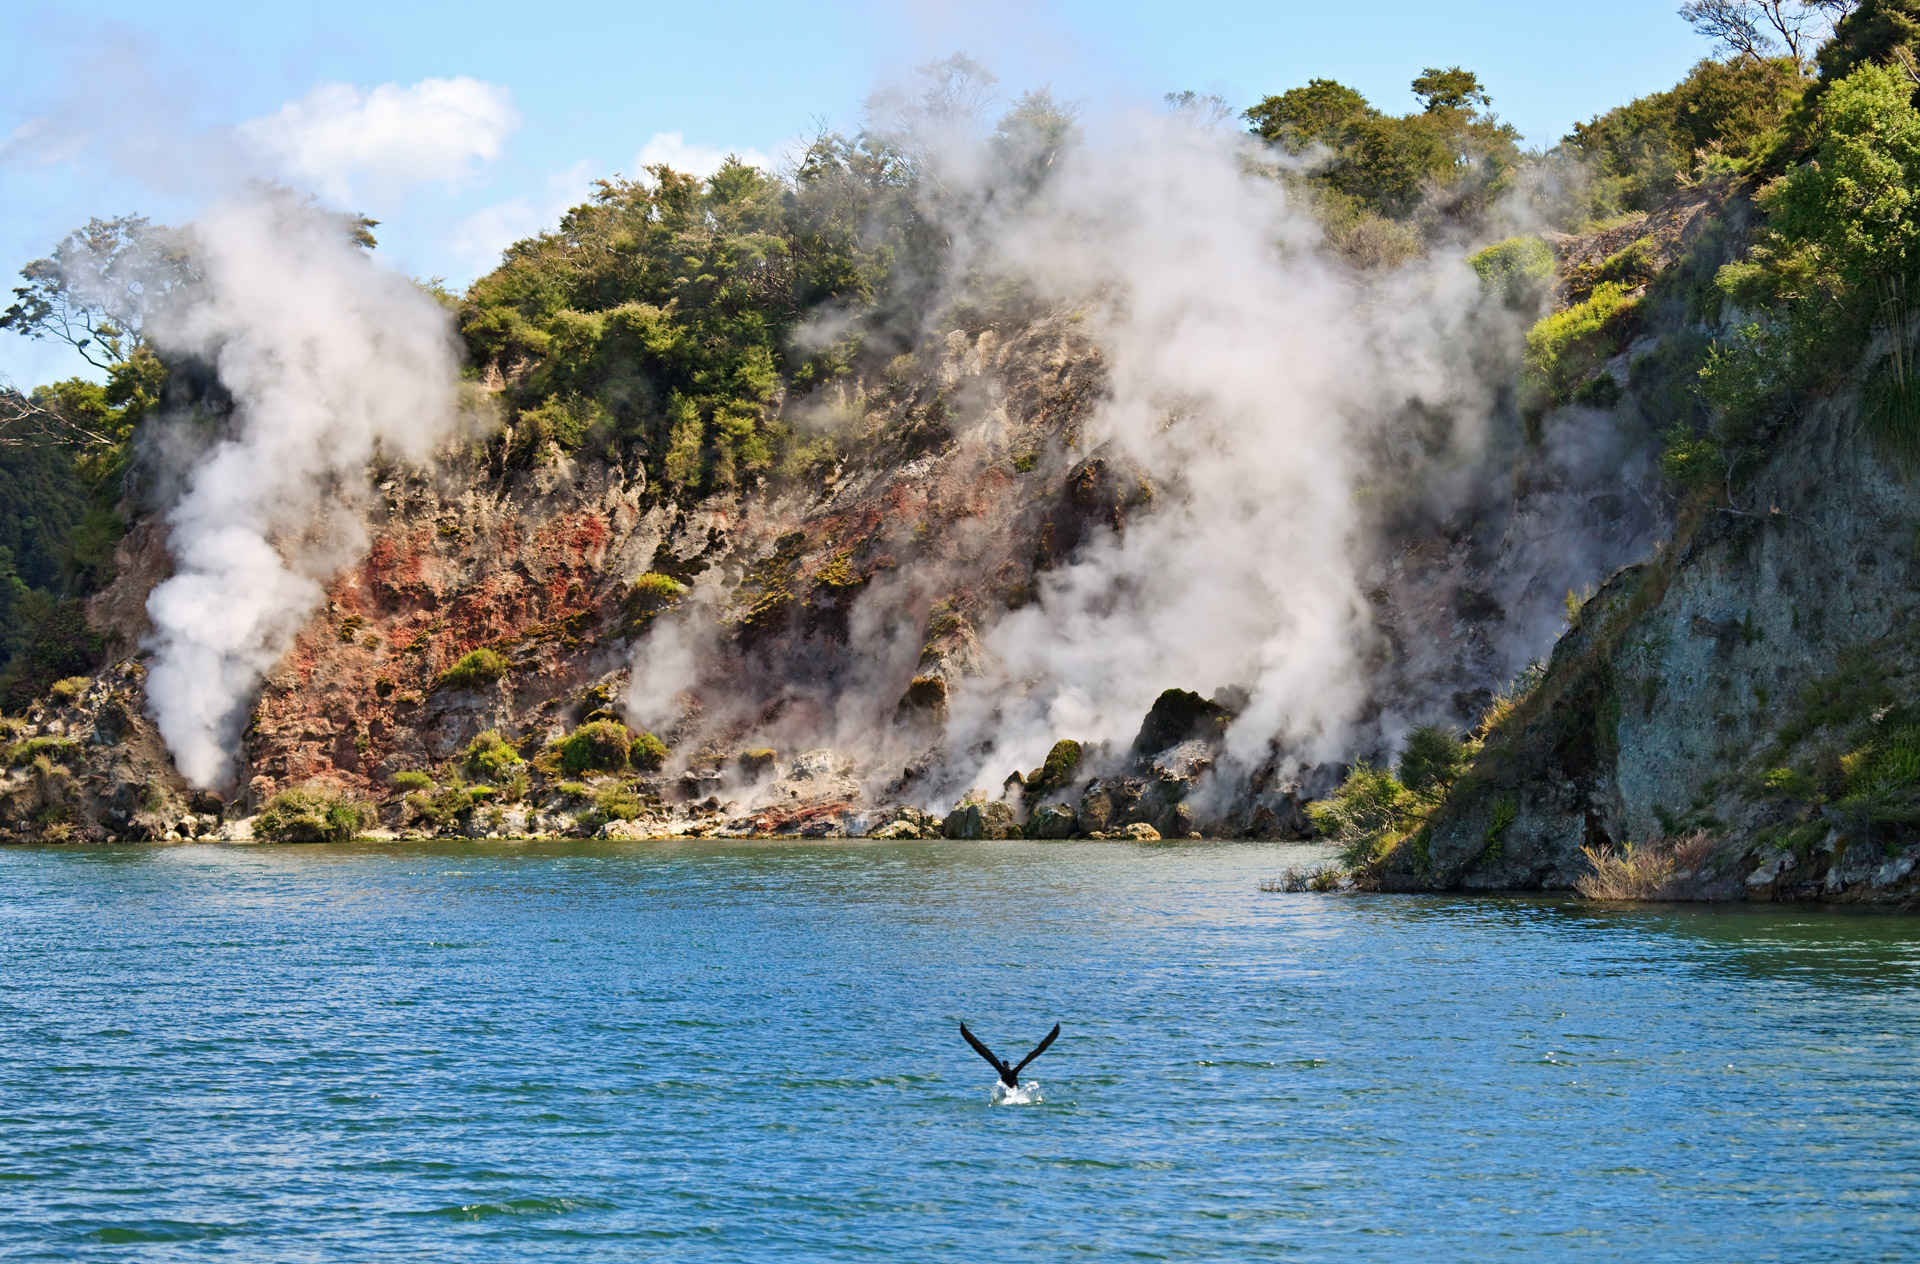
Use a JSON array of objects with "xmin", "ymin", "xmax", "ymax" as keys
[{"xmin": 4, "ymin": 286, "xmax": 1649, "ymax": 838}]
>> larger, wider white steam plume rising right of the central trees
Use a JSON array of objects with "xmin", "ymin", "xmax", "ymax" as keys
[{"xmin": 956, "ymin": 115, "xmax": 1484, "ymax": 770}]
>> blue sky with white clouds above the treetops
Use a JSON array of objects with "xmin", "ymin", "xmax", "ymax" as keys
[{"xmin": 0, "ymin": 0, "xmax": 1707, "ymax": 386}]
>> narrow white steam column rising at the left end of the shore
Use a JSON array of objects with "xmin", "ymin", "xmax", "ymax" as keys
[{"xmin": 146, "ymin": 192, "xmax": 459, "ymax": 788}]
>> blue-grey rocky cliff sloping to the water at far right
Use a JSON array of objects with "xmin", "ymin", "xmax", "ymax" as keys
[{"xmin": 1382, "ymin": 386, "xmax": 1920, "ymax": 905}]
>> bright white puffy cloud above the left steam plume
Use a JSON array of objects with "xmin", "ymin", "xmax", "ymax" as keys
[{"xmin": 238, "ymin": 77, "xmax": 520, "ymax": 202}]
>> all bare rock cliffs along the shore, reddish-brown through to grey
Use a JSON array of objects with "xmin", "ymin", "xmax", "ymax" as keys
[{"xmin": 0, "ymin": 171, "xmax": 1920, "ymax": 901}]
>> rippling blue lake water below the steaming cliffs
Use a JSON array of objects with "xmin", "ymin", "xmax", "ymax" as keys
[{"xmin": 0, "ymin": 841, "xmax": 1920, "ymax": 1264}]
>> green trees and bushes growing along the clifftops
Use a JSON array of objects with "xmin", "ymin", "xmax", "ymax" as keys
[{"xmin": 11, "ymin": 0, "xmax": 1920, "ymax": 709}]
